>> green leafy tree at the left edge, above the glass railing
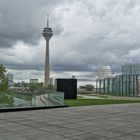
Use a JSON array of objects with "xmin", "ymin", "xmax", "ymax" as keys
[{"xmin": 0, "ymin": 64, "xmax": 8, "ymax": 91}]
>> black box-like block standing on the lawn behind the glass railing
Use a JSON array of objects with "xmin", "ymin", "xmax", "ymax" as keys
[{"xmin": 56, "ymin": 79, "xmax": 77, "ymax": 99}]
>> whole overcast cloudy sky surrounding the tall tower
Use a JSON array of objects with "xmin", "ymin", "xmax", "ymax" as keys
[{"xmin": 0, "ymin": 0, "xmax": 140, "ymax": 80}]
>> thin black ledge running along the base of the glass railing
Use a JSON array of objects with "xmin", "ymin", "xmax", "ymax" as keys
[{"xmin": 0, "ymin": 105, "xmax": 69, "ymax": 113}]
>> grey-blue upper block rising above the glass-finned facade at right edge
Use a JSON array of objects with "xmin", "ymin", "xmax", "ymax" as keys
[{"xmin": 122, "ymin": 64, "xmax": 140, "ymax": 75}]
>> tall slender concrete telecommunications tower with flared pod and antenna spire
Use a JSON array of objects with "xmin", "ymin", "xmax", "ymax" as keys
[{"xmin": 42, "ymin": 14, "xmax": 53, "ymax": 86}]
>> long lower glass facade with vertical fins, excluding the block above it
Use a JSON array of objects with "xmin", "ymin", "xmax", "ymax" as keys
[{"xmin": 96, "ymin": 75, "xmax": 140, "ymax": 96}]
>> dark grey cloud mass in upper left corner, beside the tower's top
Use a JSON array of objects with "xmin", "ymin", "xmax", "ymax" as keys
[{"xmin": 0, "ymin": 0, "xmax": 63, "ymax": 47}]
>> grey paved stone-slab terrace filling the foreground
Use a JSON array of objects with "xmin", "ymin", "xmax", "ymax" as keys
[{"xmin": 0, "ymin": 104, "xmax": 140, "ymax": 140}]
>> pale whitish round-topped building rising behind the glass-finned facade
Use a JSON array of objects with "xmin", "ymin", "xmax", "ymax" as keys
[{"xmin": 98, "ymin": 65, "xmax": 113, "ymax": 79}]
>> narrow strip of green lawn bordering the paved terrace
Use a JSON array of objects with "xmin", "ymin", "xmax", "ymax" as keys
[{"xmin": 65, "ymin": 99, "xmax": 140, "ymax": 106}]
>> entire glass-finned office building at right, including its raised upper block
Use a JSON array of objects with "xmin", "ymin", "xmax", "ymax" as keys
[{"xmin": 96, "ymin": 64, "xmax": 140, "ymax": 96}]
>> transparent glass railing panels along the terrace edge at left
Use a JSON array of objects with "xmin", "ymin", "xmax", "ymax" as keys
[{"xmin": 0, "ymin": 91, "xmax": 64, "ymax": 109}]
